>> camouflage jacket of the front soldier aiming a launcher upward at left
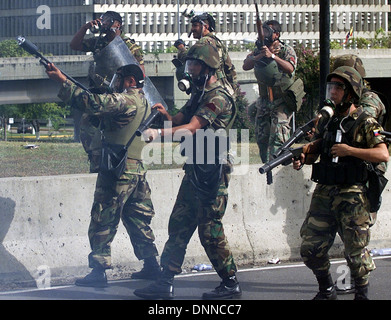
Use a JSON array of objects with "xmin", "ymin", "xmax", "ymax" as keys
[{"xmin": 58, "ymin": 80, "xmax": 149, "ymax": 152}]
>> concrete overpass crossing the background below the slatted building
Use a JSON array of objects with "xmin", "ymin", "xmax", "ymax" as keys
[{"xmin": 0, "ymin": 49, "xmax": 391, "ymax": 107}]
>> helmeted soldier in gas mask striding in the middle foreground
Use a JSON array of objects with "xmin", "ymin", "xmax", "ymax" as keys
[{"xmin": 134, "ymin": 42, "xmax": 241, "ymax": 299}]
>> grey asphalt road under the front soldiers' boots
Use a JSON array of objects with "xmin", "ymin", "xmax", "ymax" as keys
[{"xmin": 0, "ymin": 256, "xmax": 391, "ymax": 308}]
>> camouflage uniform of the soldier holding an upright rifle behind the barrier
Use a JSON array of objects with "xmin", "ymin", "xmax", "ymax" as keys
[{"xmin": 252, "ymin": 43, "xmax": 297, "ymax": 163}]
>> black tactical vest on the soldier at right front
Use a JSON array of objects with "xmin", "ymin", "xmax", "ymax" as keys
[{"xmin": 311, "ymin": 112, "xmax": 369, "ymax": 185}]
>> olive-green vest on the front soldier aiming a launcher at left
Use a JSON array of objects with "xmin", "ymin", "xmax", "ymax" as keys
[{"xmin": 103, "ymin": 95, "xmax": 151, "ymax": 160}]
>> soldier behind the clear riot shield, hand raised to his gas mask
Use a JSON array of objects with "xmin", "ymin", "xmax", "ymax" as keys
[{"xmin": 70, "ymin": 11, "xmax": 145, "ymax": 173}]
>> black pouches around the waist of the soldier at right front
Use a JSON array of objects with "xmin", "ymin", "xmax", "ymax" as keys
[{"xmin": 311, "ymin": 161, "xmax": 368, "ymax": 185}]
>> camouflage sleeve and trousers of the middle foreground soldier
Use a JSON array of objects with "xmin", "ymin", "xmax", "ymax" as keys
[{"xmin": 161, "ymin": 83, "xmax": 236, "ymax": 278}]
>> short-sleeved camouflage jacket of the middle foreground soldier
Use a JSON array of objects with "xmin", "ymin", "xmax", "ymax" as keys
[{"xmin": 179, "ymin": 82, "xmax": 236, "ymax": 130}]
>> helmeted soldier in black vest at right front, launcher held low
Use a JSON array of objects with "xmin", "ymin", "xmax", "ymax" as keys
[{"xmin": 294, "ymin": 66, "xmax": 389, "ymax": 300}]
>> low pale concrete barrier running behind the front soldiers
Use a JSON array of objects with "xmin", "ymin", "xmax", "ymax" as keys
[{"xmin": 0, "ymin": 165, "xmax": 391, "ymax": 285}]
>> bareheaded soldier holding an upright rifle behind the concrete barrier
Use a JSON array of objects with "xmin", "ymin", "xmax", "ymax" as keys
[{"xmin": 243, "ymin": 20, "xmax": 300, "ymax": 163}]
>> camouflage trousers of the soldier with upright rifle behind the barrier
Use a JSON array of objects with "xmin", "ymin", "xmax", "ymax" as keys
[{"xmin": 255, "ymin": 98, "xmax": 292, "ymax": 163}]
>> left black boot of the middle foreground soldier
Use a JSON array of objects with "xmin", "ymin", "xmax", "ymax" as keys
[{"xmin": 133, "ymin": 270, "xmax": 175, "ymax": 299}]
